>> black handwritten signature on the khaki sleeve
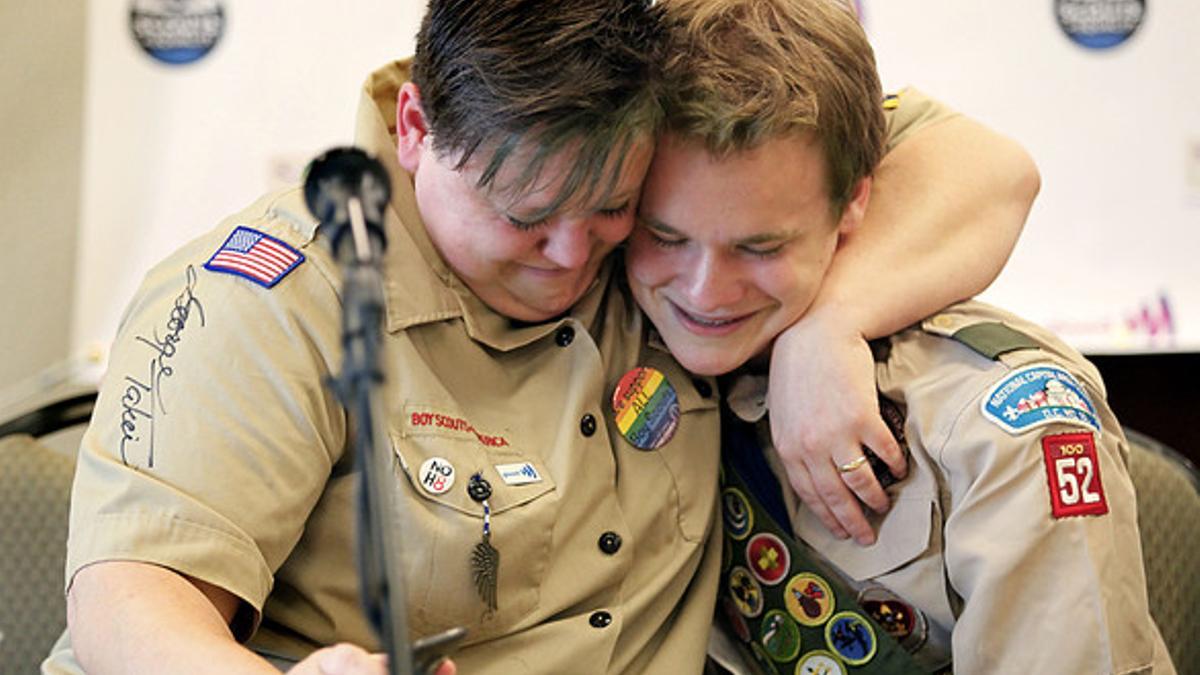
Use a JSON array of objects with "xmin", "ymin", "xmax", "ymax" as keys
[{"xmin": 121, "ymin": 265, "xmax": 204, "ymax": 467}]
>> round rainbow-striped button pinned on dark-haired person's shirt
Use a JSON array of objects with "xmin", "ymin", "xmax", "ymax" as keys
[{"xmin": 612, "ymin": 368, "xmax": 679, "ymax": 450}]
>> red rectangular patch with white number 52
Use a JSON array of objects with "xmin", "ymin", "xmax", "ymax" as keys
[{"xmin": 1042, "ymin": 432, "xmax": 1109, "ymax": 518}]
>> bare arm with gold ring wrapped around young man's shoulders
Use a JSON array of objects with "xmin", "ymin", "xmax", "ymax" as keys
[{"xmin": 768, "ymin": 111, "xmax": 1040, "ymax": 544}]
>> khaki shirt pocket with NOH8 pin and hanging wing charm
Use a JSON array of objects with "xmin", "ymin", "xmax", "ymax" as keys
[{"xmin": 391, "ymin": 417, "xmax": 558, "ymax": 643}]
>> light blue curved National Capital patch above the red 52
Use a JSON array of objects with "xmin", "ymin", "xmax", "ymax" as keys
[{"xmin": 979, "ymin": 364, "xmax": 1100, "ymax": 435}]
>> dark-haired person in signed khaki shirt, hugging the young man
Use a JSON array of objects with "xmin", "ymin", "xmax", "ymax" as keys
[{"xmin": 46, "ymin": 0, "xmax": 1041, "ymax": 673}]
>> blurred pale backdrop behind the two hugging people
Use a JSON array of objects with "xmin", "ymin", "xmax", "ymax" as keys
[{"xmin": 0, "ymin": 0, "xmax": 1200, "ymax": 453}]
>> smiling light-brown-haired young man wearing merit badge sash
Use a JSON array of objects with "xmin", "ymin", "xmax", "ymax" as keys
[{"xmin": 626, "ymin": 0, "xmax": 1174, "ymax": 675}]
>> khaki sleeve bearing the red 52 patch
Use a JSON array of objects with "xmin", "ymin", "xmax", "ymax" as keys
[{"xmin": 931, "ymin": 364, "xmax": 1156, "ymax": 674}]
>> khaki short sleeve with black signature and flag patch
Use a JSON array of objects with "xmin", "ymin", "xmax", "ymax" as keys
[{"xmin": 66, "ymin": 213, "xmax": 346, "ymax": 638}]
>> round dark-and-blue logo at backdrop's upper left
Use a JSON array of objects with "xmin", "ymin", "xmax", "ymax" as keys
[{"xmin": 130, "ymin": 0, "xmax": 226, "ymax": 65}]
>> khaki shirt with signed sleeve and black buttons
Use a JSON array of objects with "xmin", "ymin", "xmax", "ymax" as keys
[{"xmin": 47, "ymin": 64, "xmax": 720, "ymax": 674}]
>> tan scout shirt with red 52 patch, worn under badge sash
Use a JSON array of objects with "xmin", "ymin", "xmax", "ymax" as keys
[{"xmin": 720, "ymin": 301, "xmax": 1175, "ymax": 674}]
